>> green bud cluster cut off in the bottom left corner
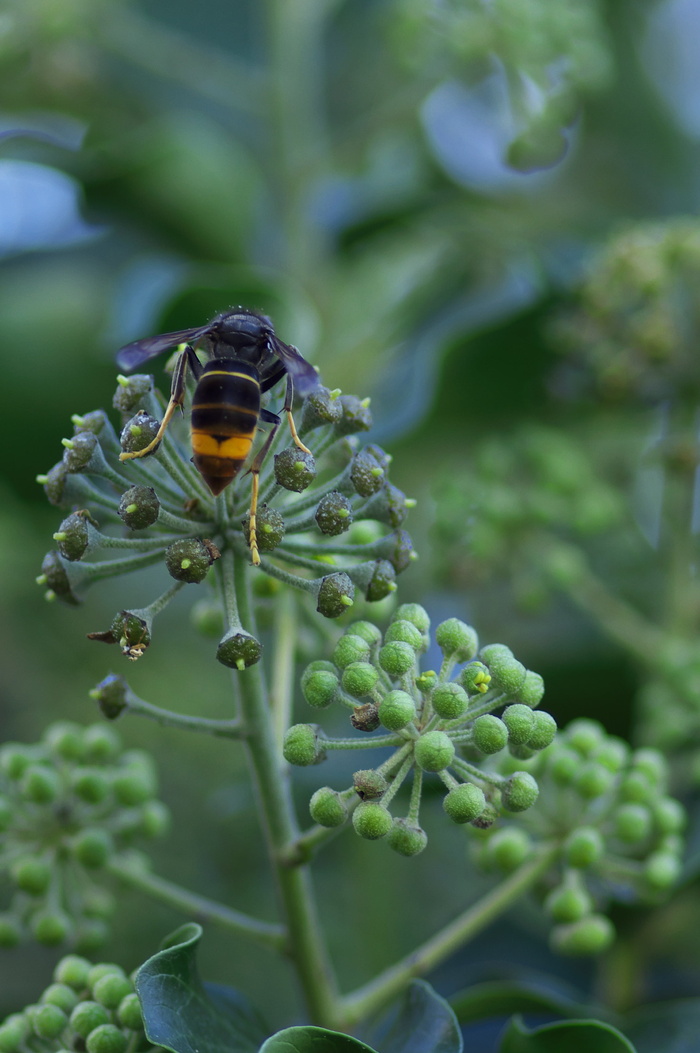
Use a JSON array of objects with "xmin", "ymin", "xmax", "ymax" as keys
[{"xmin": 0, "ymin": 954, "xmax": 159, "ymax": 1053}]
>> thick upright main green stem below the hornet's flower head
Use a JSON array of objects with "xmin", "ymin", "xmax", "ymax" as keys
[{"xmin": 229, "ymin": 552, "xmax": 338, "ymax": 1027}]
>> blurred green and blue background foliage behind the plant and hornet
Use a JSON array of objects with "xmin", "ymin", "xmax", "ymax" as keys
[{"xmin": 0, "ymin": 0, "xmax": 700, "ymax": 1036}]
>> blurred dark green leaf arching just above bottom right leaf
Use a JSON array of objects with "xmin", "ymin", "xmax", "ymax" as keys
[{"xmin": 449, "ymin": 980, "xmax": 599, "ymax": 1024}]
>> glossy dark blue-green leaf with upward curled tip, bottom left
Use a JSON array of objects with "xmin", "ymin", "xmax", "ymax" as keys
[{"xmin": 136, "ymin": 923, "xmax": 268, "ymax": 1053}]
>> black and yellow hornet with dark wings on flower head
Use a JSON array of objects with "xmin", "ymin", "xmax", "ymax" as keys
[{"xmin": 117, "ymin": 307, "xmax": 319, "ymax": 565}]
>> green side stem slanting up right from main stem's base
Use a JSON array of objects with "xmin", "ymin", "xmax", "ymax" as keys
[{"xmin": 341, "ymin": 847, "xmax": 559, "ymax": 1029}]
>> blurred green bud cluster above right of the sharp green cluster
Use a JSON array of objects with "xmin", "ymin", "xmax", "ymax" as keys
[{"xmin": 436, "ymin": 426, "xmax": 626, "ymax": 609}]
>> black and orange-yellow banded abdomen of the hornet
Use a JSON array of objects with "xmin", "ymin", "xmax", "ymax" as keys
[{"xmin": 192, "ymin": 358, "xmax": 260, "ymax": 494}]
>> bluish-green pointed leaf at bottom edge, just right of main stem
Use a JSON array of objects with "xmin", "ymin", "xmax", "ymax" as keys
[{"xmin": 362, "ymin": 980, "xmax": 462, "ymax": 1053}]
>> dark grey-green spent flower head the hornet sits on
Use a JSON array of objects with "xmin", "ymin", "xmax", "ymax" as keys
[{"xmin": 37, "ymin": 383, "xmax": 415, "ymax": 669}]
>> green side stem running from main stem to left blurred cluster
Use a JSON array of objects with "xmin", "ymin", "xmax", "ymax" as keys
[{"xmin": 107, "ymin": 858, "xmax": 286, "ymax": 950}]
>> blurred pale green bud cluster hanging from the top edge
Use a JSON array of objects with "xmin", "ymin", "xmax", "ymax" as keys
[{"xmin": 392, "ymin": 0, "xmax": 613, "ymax": 172}]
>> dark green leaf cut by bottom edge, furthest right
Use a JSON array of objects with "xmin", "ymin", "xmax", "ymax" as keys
[{"xmin": 499, "ymin": 1016, "xmax": 637, "ymax": 1053}]
